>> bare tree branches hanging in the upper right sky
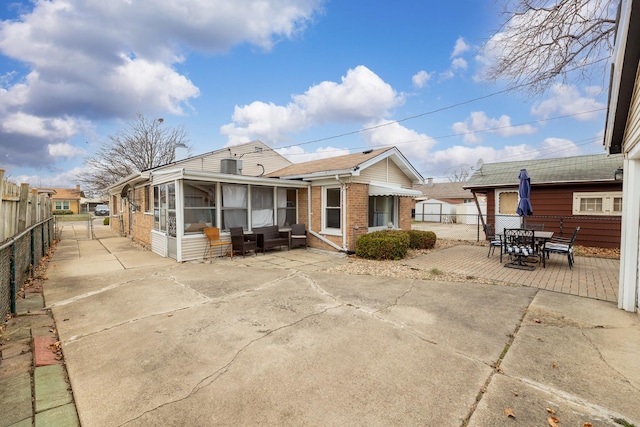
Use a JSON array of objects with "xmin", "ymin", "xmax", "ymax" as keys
[{"xmin": 482, "ymin": 0, "xmax": 620, "ymax": 94}]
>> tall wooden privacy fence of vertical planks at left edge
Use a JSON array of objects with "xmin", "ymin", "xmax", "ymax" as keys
[{"xmin": 0, "ymin": 169, "xmax": 53, "ymax": 243}]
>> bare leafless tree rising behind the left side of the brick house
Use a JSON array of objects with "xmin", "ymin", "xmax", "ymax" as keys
[{"xmin": 78, "ymin": 113, "xmax": 191, "ymax": 192}]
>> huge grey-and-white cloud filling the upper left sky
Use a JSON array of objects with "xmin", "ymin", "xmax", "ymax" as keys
[{"xmin": 0, "ymin": 0, "xmax": 325, "ymax": 166}]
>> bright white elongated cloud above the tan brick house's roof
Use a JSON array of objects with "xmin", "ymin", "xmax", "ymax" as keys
[{"xmin": 220, "ymin": 65, "xmax": 404, "ymax": 145}]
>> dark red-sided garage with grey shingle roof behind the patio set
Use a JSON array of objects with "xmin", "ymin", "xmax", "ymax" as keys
[{"xmin": 464, "ymin": 154, "xmax": 622, "ymax": 248}]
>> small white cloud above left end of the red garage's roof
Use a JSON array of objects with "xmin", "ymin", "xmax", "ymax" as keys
[{"xmin": 451, "ymin": 111, "xmax": 537, "ymax": 144}]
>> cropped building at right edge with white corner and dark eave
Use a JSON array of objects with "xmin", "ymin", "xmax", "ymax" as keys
[{"xmin": 604, "ymin": 0, "xmax": 640, "ymax": 311}]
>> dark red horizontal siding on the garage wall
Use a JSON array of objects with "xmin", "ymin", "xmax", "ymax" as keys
[{"xmin": 487, "ymin": 182, "xmax": 622, "ymax": 248}]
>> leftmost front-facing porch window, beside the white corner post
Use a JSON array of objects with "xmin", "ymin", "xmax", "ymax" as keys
[{"xmin": 183, "ymin": 181, "xmax": 216, "ymax": 234}]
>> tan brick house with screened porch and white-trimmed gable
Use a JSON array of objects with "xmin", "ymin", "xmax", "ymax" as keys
[{"xmin": 109, "ymin": 141, "xmax": 422, "ymax": 262}]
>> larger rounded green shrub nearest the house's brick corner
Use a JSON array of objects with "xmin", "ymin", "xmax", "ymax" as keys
[{"xmin": 356, "ymin": 230, "xmax": 409, "ymax": 260}]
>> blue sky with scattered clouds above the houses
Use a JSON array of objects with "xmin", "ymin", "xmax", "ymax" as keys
[{"xmin": 0, "ymin": 0, "xmax": 608, "ymax": 187}]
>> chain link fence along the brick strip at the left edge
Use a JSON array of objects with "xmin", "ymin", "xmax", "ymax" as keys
[{"xmin": 0, "ymin": 218, "xmax": 56, "ymax": 318}]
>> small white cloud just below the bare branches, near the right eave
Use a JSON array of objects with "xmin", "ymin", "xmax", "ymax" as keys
[{"xmin": 531, "ymin": 84, "xmax": 605, "ymax": 121}]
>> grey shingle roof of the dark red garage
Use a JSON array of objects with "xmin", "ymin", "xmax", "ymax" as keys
[{"xmin": 464, "ymin": 154, "xmax": 623, "ymax": 189}]
